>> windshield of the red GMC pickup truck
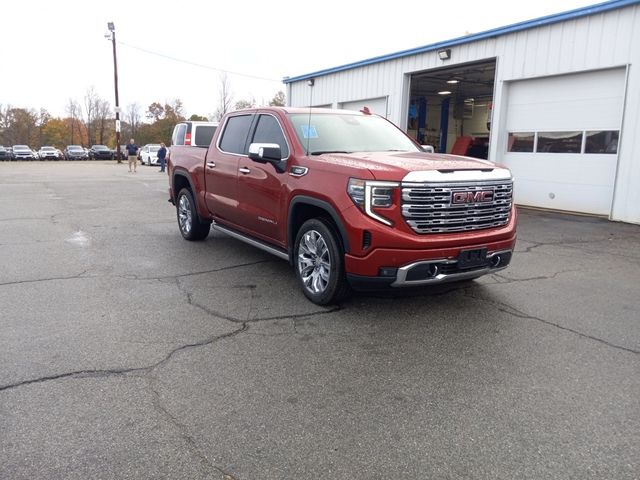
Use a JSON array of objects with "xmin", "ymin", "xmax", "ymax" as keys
[{"xmin": 289, "ymin": 112, "xmax": 419, "ymax": 155}]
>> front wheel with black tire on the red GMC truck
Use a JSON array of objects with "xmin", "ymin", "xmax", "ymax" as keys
[{"xmin": 293, "ymin": 218, "xmax": 349, "ymax": 305}]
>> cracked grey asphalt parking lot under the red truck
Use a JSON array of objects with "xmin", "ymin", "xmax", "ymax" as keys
[{"xmin": 0, "ymin": 161, "xmax": 640, "ymax": 480}]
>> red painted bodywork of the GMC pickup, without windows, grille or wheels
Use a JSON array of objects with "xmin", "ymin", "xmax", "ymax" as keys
[{"xmin": 169, "ymin": 108, "xmax": 517, "ymax": 284}]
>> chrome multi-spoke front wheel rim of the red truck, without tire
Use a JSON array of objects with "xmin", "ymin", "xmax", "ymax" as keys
[{"xmin": 298, "ymin": 230, "xmax": 331, "ymax": 294}]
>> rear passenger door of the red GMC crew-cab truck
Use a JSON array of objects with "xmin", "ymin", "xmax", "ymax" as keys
[{"xmin": 204, "ymin": 114, "xmax": 254, "ymax": 226}]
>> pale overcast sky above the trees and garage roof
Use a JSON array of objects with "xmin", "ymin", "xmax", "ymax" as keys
[{"xmin": 0, "ymin": 0, "xmax": 597, "ymax": 116}]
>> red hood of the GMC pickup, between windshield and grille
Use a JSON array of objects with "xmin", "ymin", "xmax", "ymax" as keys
[{"xmin": 322, "ymin": 152, "xmax": 499, "ymax": 181}]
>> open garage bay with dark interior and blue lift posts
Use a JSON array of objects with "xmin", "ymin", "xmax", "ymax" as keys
[{"xmin": 407, "ymin": 58, "xmax": 496, "ymax": 158}]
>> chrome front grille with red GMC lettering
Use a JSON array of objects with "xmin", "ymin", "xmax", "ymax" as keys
[{"xmin": 402, "ymin": 180, "xmax": 513, "ymax": 233}]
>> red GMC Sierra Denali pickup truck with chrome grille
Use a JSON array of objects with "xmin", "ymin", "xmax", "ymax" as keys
[{"xmin": 168, "ymin": 107, "xmax": 516, "ymax": 305}]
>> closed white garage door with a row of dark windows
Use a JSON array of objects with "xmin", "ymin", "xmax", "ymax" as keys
[{"xmin": 503, "ymin": 68, "xmax": 626, "ymax": 215}]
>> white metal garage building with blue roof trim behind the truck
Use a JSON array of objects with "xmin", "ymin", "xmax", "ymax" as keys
[{"xmin": 284, "ymin": 0, "xmax": 640, "ymax": 223}]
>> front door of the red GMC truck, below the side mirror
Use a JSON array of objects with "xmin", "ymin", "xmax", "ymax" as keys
[{"xmin": 237, "ymin": 113, "xmax": 289, "ymax": 246}]
